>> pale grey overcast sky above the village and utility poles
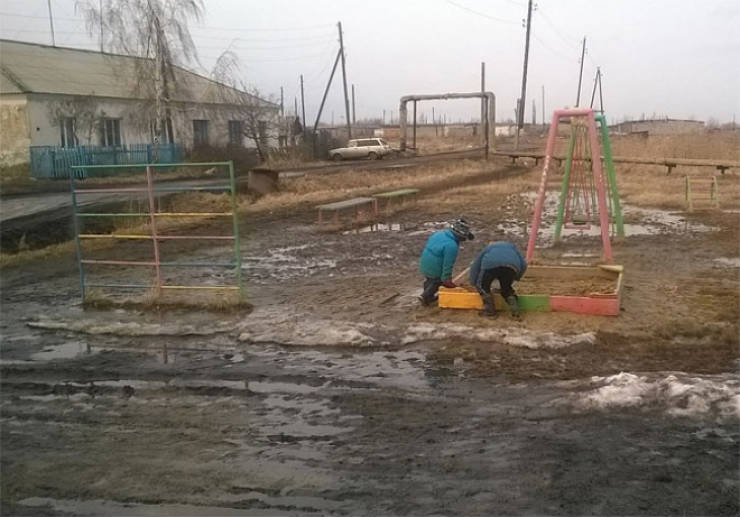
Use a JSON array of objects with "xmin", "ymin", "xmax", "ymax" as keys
[{"xmin": 0, "ymin": 0, "xmax": 740, "ymax": 124}]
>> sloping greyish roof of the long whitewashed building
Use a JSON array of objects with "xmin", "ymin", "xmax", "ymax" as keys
[{"xmin": 0, "ymin": 39, "xmax": 272, "ymax": 104}]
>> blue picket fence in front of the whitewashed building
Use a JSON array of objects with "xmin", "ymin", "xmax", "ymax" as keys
[{"xmin": 30, "ymin": 144, "xmax": 182, "ymax": 179}]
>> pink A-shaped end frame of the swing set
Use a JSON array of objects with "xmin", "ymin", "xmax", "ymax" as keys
[{"xmin": 527, "ymin": 108, "xmax": 612, "ymax": 262}]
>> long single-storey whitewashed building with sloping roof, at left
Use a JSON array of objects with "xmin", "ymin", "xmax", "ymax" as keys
[{"xmin": 0, "ymin": 40, "xmax": 279, "ymax": 171}]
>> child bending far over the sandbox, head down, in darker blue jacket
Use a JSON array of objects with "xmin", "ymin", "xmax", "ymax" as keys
[{"xmin": 470, "ymin": 241, "xmax": 527, "ymax": 318}]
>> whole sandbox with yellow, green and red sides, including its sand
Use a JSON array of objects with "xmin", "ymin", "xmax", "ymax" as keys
[{"xmin": 439, "ymin": 265, "xmax": 622, "ymax": 316}]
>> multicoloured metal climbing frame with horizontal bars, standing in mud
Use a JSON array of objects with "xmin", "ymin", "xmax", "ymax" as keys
[{"xmin": 69, "ymin": 161, "xmax": 245, "ymax": 302}]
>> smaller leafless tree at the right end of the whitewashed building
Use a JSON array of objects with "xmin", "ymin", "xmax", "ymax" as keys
[{"xmin": 211, "ymin": 50, "xmax": 280, "ymax": 161}]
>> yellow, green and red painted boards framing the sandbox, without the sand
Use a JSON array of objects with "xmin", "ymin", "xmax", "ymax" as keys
[{"xmin": 439, "ymin": 265, "xmax": 623, "ymax": 316}]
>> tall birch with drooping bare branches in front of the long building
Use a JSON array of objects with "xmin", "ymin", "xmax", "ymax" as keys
[{"xmin": 76, "ymin": 0, "xmax": 204, "ymax": 161}]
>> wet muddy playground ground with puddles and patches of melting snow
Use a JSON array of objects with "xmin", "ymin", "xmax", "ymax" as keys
[{"xmin": 0, "ymin": 155, "xmax": 740, "ymax": 515}]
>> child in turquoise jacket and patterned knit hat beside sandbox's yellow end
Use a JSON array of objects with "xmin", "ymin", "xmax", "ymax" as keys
[{"xmin": 419, "ymin": 218, "xmax": 475, "ymax": 305}]
